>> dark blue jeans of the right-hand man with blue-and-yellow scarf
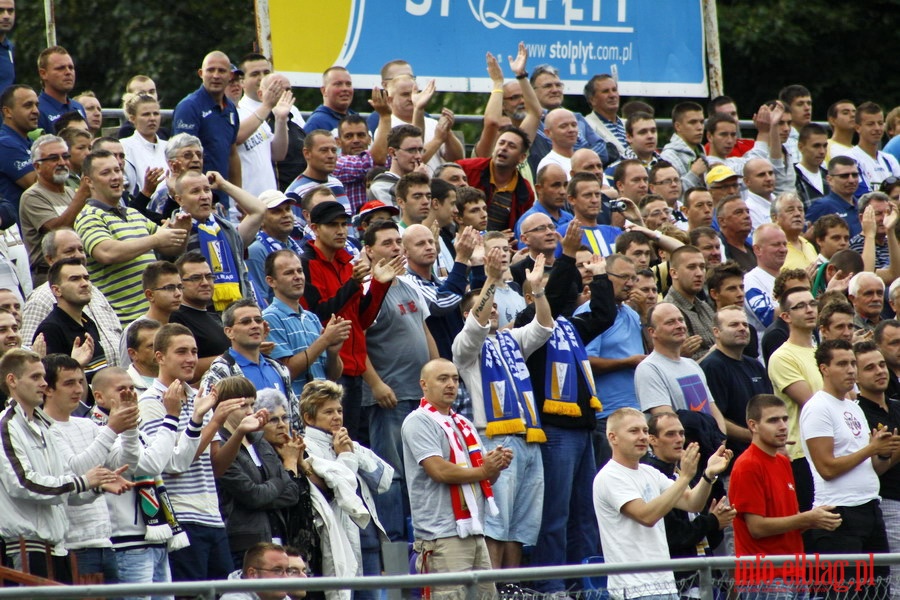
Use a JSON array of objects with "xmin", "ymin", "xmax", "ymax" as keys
[{"xmin": 531, "ymin": 425, "xmax": 600, "ymax": 592}]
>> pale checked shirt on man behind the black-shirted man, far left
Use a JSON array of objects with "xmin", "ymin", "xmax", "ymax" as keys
[{"xmin": 19, "ymin": 282, "xmax": 122, "ymax": 367}]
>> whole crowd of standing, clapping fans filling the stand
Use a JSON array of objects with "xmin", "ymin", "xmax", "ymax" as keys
[{"xmin": 0, "ymin": 5, "xmax": 900, "ymax": 600}]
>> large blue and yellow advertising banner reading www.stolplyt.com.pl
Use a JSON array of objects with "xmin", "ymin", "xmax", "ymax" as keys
[{"xmin": 268, "ymin": 0, "xmax": 708, "ymax": 97}]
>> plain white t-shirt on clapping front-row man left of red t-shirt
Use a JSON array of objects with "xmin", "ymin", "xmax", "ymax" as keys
[{"xmin": 593, "ymin": 460, "xmax": 678, "ymax": 600}]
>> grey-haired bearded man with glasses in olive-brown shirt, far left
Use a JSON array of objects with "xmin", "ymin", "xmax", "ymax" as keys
[{"xmin": 19, "ymin": 135, "xmax": 90, "ymax": 287}]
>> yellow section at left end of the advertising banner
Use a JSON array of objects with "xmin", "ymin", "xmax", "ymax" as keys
[{"xmin": 269, "ymin": 0, "xmax": 356, "ymax": 73}]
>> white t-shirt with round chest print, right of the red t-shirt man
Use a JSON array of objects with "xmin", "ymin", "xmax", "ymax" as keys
[{"xmin": 800, "ymin": 390, "xmax": 880, "ymax": 506}]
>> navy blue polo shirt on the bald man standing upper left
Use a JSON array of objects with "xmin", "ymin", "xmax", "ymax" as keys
[{"xmin": 172, "ymin": 85, "xmax": 241, "ymax": 179}]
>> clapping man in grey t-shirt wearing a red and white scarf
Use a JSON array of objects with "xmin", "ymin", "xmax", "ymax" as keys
[{"xmin": 402, "ymin": 358, "xmax": 513, "ymax": 598}]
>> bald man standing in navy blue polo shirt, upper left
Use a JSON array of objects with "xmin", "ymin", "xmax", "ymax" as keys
[{"xmin": 172, "ymin": 50, "xmax": 241, "ymax": 198}]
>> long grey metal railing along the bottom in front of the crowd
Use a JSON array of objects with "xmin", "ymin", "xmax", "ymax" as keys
[{"xmin": 0, "ymin": 553, "xmax": 900, "ymax": 600}]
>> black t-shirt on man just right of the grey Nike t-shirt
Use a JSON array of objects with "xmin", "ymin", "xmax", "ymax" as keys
[{"xmin": 700, "ymin": 349, "xmax": 772, "ymax": 458}]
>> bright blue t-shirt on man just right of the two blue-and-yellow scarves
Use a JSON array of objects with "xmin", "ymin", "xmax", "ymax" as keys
[{"xmin": 575, "ymin": 303, "xmax": 644, "ymax": 419}]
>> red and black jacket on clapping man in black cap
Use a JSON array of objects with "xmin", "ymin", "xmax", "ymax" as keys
[{"xmin": 301, "ymin": 242, "xmax": 390, "ymax": 376}]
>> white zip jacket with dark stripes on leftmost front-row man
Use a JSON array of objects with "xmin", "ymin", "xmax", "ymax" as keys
[{"xmin": 0, "ymin": 401, "xmax": 87, "ymax": 555}]
